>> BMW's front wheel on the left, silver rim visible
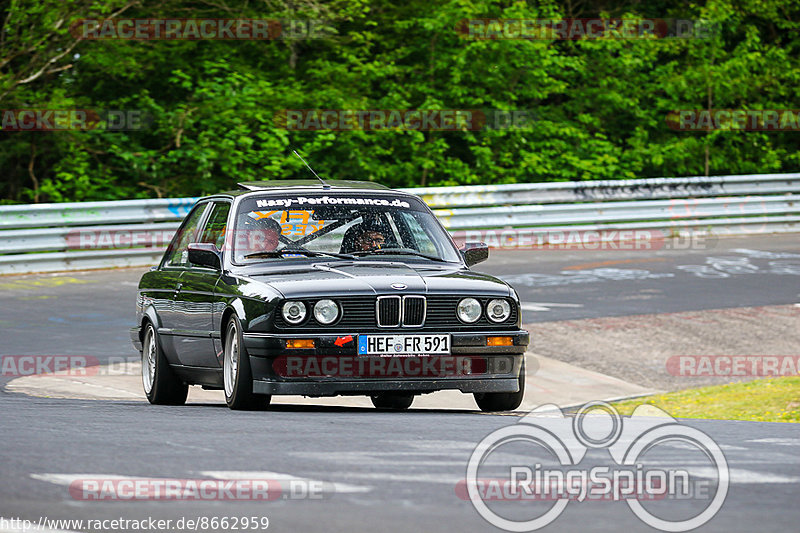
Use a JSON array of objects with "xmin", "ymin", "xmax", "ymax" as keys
[{"xmin": 222, "ymin": 315, "xmax": 272, "ymax": 411}]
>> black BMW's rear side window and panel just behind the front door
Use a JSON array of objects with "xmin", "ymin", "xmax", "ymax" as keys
[{"xmin": 151, "ymin": 202, "xmax": 209, "ymax": 364}]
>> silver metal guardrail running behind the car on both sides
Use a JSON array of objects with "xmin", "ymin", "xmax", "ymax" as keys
[{"xmin": 0, "ymin": 173, "xmax": 800, "ymax": 274}]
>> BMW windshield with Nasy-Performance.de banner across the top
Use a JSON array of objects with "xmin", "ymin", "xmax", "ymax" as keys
[{"xmin": 225, "ymin": 192, "xmax": 460, "ymax": 264}]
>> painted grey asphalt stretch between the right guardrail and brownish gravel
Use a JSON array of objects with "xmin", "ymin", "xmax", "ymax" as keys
[{"xmin": 488, "ymin": 234, "xmax": 800, "ymax": 323}]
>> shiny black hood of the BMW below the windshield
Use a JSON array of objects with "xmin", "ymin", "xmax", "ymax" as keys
[{"xmin": 242, "ymin": 262, "xmax": 511, "ymax": 298}]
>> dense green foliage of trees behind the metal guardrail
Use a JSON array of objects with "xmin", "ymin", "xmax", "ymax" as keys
[{"xmin": 0, "ymin": 0, "xmax": 800, "ymax": 202}]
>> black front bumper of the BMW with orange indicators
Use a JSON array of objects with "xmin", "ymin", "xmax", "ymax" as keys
[{"xmin": 244, "ymin": 330, "xmax": 529, "ymax": 396}]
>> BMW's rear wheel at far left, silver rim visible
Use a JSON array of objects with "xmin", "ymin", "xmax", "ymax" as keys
[{"xmin": 142, "ymin": 322, "xmax": 189, "ymax": 405}]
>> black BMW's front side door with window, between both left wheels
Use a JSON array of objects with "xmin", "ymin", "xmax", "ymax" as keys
[{"xmin": 174, "ymin": 201, "xmax": 231, "ymax": 369}]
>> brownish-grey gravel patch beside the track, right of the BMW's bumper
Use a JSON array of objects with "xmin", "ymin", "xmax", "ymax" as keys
[{"xmin": 525, "ymin": 305, "xmax": 800, "ymax": 391}]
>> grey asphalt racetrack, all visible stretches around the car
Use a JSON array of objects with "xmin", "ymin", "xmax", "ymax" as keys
[{"xmin": 0, "ymin": 235, "xmax": 800, "ymax": 532}]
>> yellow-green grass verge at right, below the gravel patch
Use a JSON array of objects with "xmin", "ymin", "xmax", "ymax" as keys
[{"xmin": 613, "ymin": 376, "xmax": 800, "ymax": 422}]
